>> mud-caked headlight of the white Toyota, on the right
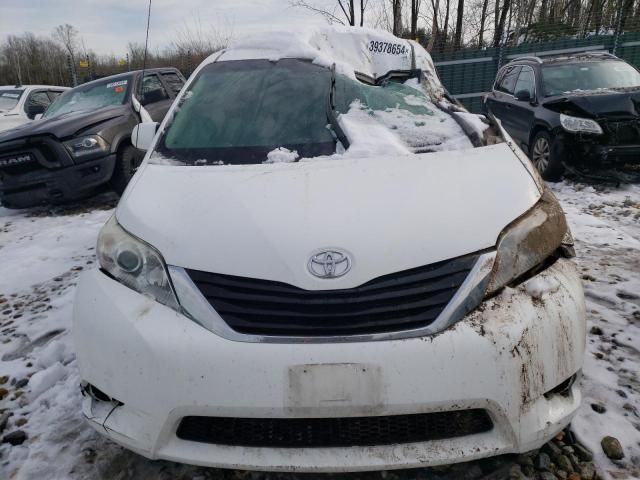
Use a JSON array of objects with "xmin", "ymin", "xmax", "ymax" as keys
[{"xmin": 487, "ymin": 189, "xmax": 573, "ymax": 295}]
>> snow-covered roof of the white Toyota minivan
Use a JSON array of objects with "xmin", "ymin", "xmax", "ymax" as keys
[{"xmin": 208, "ymin": 26, "xmax": 444, "ymax": 98}]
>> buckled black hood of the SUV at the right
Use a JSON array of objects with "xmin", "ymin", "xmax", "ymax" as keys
[{"xmin": 543, "ymin": 89, "xmax": 640, "ymax": 118}]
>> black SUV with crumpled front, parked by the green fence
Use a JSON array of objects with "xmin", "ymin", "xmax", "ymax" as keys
[{"xmin": 483, "ymin": 52, "xmax": 640, "ymax": 181}]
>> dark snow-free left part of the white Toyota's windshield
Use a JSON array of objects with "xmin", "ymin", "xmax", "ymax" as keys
[{"xmin": 156, "ymin": 59, "xmax": 336, "ymax": 164}]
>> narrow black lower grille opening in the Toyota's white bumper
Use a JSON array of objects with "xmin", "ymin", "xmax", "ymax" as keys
[{"xmin": 176, "ymin": 409, "xmax": 493, "ymax": 448}]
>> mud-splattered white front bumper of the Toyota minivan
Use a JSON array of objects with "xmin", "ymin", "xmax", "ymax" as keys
[{"xmin": 74, "ymin": 259, "xmax": 585, "ymax": 471}]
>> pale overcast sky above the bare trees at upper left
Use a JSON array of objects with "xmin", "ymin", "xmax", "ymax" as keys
[{"xmin": 0, "ymin": 0, "xmax": 325, "ymax": 56}]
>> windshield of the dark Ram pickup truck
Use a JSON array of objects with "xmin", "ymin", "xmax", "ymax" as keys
[{"xmin": 43, "ymin": 77, "xmax": 131, "ymax": 118}]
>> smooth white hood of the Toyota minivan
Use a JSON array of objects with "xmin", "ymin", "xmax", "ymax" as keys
[{"xmin": 116, "ymin": 144, "xmax": 540, "ymax": 290}]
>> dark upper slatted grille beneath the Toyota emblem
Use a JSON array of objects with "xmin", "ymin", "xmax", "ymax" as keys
[{"xmin": 188, "ymin": 255, "xmax": 478, "ymax": 336}]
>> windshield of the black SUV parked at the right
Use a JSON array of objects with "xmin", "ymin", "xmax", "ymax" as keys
[{"xmin": 542, "ymin": 61, "xmax": 640, "ymax": 97}]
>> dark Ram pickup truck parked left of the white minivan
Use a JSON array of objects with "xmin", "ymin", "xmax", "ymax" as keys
[{"xmin": 0, "ymin": 68, "xmax": 185, "ymax": 208}]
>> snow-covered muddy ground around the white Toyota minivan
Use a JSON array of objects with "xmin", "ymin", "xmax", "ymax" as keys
[{"xmin": 0, "ymin": 183, "xmax": 640, "ymax": 480}]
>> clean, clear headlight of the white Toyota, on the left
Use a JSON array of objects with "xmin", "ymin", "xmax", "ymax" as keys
[{"xmin": 97, "ymin": 215, "xmax": 180, "ymax": 311}]
